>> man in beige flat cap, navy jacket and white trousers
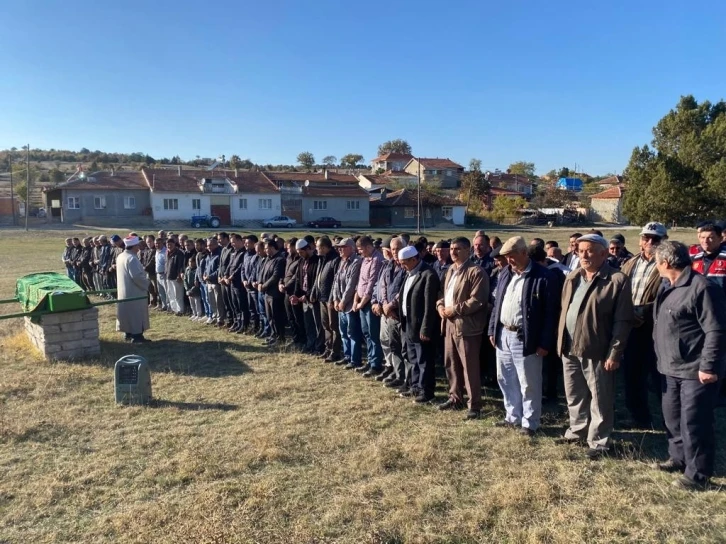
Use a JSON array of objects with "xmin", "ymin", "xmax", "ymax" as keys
[{"xmin": 489, "ymin": 236, "xmax": 558, "ymax": 436}]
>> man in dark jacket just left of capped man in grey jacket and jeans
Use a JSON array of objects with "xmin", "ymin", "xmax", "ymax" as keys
[{"xmin": 312, "ymin": 236, "xmax": 342, "ymax": 363}]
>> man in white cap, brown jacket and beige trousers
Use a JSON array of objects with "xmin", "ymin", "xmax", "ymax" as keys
[{"xmin": 557, "ymin": 234, "xmax": 633, "ymax": 459}]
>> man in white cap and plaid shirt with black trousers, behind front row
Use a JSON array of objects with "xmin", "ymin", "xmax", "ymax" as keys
[{"xmin": 622, "ymin": 223, "xmax": 668, "ymax": 429}]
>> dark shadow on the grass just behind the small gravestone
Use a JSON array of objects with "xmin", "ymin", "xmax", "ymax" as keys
[{"xmin": 60, "ymin": 339, "xmax": 259, "ymax": 378}]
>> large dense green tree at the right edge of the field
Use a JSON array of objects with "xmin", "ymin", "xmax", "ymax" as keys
[{"xmin": 623, "ymin": 95, "xmax": 726, "ymax": 225}]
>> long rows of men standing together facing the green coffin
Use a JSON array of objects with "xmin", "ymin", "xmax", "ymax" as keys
[{"xmin": 63, "ymin": 223, "xmax": 726, "ymax": 489}]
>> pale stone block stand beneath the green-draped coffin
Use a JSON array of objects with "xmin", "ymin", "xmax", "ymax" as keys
[{"xmin": 24, "ymin": 308, "xmax": 101, "ymax": 361}]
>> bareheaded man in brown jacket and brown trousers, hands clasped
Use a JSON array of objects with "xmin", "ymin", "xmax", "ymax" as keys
[{"xmin": 436, "ymin": 237, "xmax": 489, "ymax": 419}]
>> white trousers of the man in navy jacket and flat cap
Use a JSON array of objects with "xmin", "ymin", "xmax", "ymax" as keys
[{"xmin": 497, "ymin": 327, "xmax": 542, "ymax": 431}]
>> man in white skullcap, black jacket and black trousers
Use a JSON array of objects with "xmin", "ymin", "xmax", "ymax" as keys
[{"xmin": 398, "ymin": 246, "xmax": 441, "ymax": 403}]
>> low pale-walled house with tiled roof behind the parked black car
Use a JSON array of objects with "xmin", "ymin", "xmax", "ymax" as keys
[{"xmin": 264, "ymin": 170, "xmax": 369, "ymax": 227}]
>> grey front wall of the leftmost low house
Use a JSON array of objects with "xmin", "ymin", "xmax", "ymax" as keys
[{"xmin": 61, "ymin": 189, "xmax": 151, "ymax": 225}]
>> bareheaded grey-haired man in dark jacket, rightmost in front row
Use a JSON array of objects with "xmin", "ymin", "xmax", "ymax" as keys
[{"xmin": 653, "ymin": 241, "xmax": 726, "ymax": 490}]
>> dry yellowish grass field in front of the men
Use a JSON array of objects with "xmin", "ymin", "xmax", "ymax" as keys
[{"xmin": 0, "ymin": 229, "xmax": 726, "ymax": 543}]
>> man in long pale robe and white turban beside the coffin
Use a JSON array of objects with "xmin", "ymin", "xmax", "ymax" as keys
[{"xmin": 116, "ymin": 236, "xmax": 149, "ymax": 344}]
